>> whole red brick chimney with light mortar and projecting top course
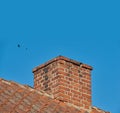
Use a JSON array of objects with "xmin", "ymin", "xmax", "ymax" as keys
[{"xmin": 33, "ymin": 56, "xmax": 92, "ymax": 109}]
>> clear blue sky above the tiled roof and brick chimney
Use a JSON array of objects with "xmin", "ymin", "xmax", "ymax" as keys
[{"xmin": 0, "ymin": 0, "xmax": 120, "ymax": 113}]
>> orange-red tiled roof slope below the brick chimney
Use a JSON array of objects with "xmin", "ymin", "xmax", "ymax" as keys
[{"xmin": 0, "ymin": 79, "xmax": 81, "ymax": 113}]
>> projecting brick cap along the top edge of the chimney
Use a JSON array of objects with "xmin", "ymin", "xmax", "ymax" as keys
[{"xmin": 33, "ymin": 56, "xmax": 93, "ymax": 72}]
